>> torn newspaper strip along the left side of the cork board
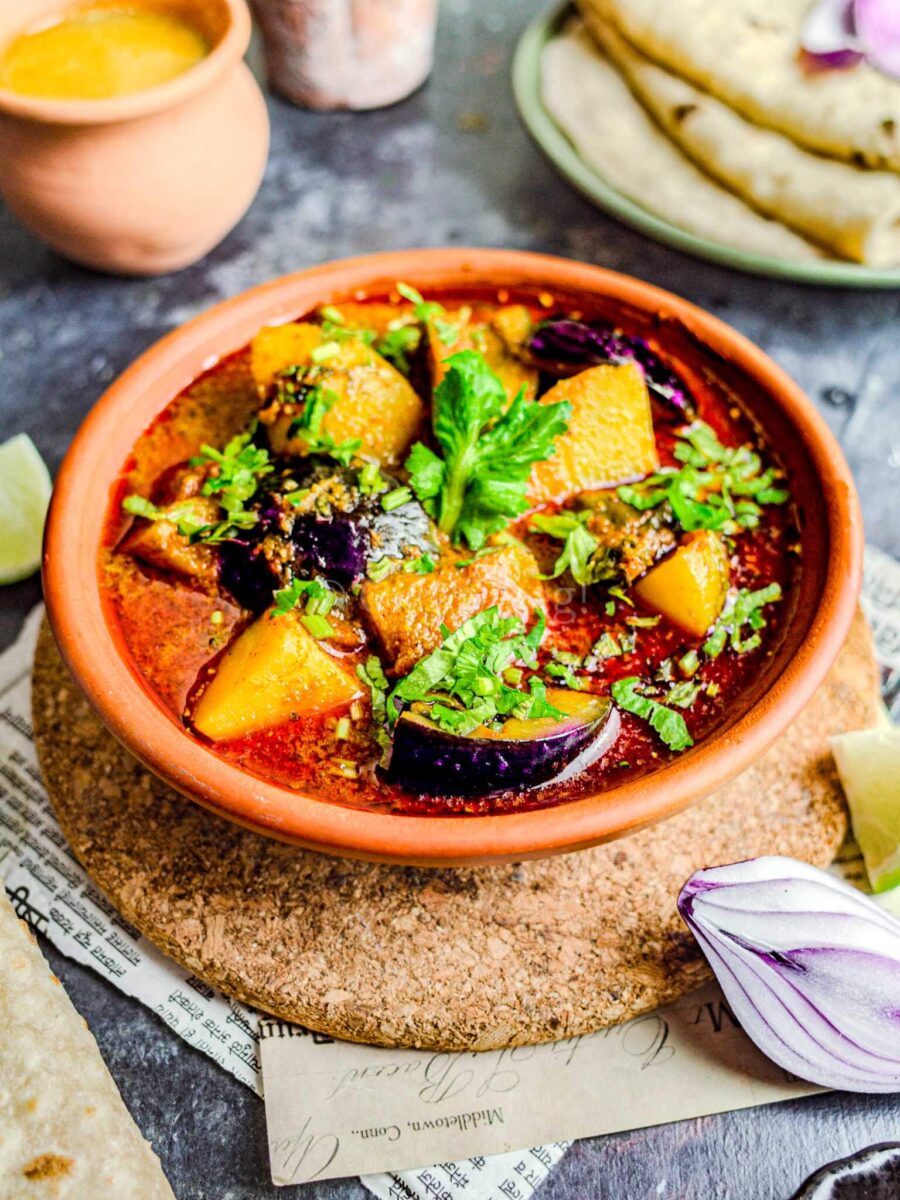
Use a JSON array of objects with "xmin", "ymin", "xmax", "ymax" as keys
[{"xmin": 0, "ymin": 608, "xmax": 263, "ymax": 1093}]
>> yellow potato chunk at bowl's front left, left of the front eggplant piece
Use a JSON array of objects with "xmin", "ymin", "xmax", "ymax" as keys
[{"xmin": 193, "ymin": 611, "xmax": 362, "ymax": 742}]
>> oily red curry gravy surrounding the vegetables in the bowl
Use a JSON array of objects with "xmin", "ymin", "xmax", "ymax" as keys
[{"xmin": 100, "ymin": 293, "xmax": 800, "ymax": 814}]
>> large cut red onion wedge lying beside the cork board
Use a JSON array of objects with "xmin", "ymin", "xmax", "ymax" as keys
[{"xmin": 678, "ymin": 857, "xmax": 900, "ymax": 1092}]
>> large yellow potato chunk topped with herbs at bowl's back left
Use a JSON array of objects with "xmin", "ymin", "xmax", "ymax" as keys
[{"xmin": 250, "ymin": 324, "xmax": 425, "ymax": 466}]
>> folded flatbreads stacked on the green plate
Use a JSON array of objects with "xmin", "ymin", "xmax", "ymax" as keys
[{"xmin": 541, "ymin": 0, "xmax": 900, "ymax": 268}]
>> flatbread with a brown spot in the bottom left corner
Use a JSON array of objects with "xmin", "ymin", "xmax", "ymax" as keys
[{"xmin": 0, "ymin": 883, "xmax": 175, "ymax": 1200}]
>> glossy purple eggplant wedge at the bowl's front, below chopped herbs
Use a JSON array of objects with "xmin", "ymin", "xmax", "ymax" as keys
[{"xmin": 386, "ymin": 688, "xmax": 619, "ymax": 796}]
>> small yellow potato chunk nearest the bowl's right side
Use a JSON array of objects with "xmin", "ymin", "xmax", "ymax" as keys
[{"xmin": 634, "ymin": 529, "xmax": 730, "ymax": 637}]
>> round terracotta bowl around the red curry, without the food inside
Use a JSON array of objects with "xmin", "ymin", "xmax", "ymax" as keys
[{"xmin": 43, "ymin": 250, "xmax": 863, "ymax": 865}]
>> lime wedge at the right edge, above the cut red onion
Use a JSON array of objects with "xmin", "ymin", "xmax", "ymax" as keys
[{"xmin": 832, "ymin": 726, "xmax": 900, "ymax": 892}]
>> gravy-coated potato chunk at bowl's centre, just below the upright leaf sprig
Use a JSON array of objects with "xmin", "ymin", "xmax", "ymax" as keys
[{"xmin": 361, "ymin": 542, "xmax": 545, "ymax": 674}]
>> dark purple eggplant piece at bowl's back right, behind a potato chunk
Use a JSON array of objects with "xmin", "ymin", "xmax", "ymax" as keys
[{"xmin": 527, "ymin": 317, "xmax": 697, "ymax": 421}]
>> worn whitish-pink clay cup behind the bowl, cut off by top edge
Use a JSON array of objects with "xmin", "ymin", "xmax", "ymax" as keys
[{"xmin": 251, "ymin": 0, "xmax": 438, "ymax": 109}]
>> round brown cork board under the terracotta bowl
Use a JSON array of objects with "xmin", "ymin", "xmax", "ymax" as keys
[{"xmin": 34, "ymin": 617, "xmax": 878, "ymax": 1050}]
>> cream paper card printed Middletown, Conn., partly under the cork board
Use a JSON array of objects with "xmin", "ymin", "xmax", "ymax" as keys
[{"xmin": 260, "ymin": 984, "xmax": 820, "ymax": 1185}]
